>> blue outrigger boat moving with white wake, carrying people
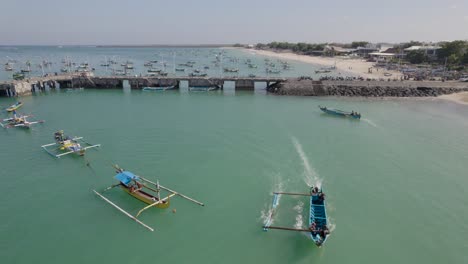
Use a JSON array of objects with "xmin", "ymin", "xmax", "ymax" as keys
[{"xmin": 263, "ymin": 187, "xmax": 330, "ymax": 247}]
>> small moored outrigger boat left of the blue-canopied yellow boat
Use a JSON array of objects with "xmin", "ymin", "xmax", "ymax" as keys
[{"xmin": 41, "ymin": 130, "xmax": 101, "ymax": 158}]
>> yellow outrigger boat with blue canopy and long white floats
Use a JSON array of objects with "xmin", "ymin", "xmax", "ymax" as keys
[{"xmin": 93, "ymin": 165, "xmax": 205, "ymax": 231}]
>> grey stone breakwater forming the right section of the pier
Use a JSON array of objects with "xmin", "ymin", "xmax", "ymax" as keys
[{"xmin": 268, "ymin": 78, "xmax": 468, "ymax": 97}]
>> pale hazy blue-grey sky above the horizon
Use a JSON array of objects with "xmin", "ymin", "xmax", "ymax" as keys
[{"xmin": 0, "ymin": 0, "xmax": 468, "ymax": 45}]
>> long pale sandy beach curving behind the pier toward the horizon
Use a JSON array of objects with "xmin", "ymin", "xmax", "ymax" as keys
[{"xmin": 243, "ymin": 49, "xmax": 401, "ymax": 79}]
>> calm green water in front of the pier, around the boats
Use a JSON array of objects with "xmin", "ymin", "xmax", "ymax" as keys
[{"xmin": 0, "ymin": 90, "xmax": 468, "ymax": 263}]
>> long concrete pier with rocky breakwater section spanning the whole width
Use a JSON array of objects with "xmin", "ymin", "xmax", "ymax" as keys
[{"xmin": 0, "ymin": 73, "xmax": 468, "ymax": 97}]
